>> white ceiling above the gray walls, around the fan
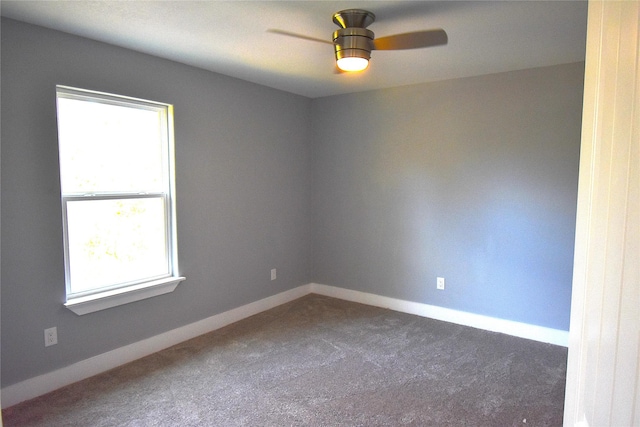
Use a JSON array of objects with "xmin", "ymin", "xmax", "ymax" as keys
[{"xmin": 0, "ymin": 0, "xmax": 587, "ymax": 98}]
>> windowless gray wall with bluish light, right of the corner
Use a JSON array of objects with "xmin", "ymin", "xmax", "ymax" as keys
[{"xmin": 312, "ymin": 63, "xmax": 584, "ymax": 330}]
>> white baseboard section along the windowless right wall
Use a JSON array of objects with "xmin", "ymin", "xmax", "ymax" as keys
[{"xmin": 311, "ymin": 283, "xmax": 569, "ymax": 347}]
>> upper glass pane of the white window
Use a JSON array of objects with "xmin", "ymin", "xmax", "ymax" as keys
[{"xmin": 58, "ymin": 97, "xmax": 166, "ymax": 194}]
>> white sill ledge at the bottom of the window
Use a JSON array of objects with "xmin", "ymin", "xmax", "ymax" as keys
[{"xmin": 65, "ymin": 277, "xmax": 185, "ymax": 316}]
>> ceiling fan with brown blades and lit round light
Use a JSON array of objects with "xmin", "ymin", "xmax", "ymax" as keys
[{"xmin": 267, "ymin": 9, "xmax": 448, "ymax": 71}]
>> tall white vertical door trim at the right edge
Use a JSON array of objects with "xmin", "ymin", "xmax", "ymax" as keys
[{"xmin": 564, "ymin": 0, "xmax": 640, "ymax": 427}]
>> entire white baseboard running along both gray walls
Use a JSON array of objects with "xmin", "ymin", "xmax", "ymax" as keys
[{"xmin": 0, "ymin": 283, "xmax": 569, "ymax": 408}]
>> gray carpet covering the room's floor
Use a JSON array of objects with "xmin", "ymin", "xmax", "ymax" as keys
[{"xmin": 3, "ymin": 295, "xmax": 567, "ymax": 426}]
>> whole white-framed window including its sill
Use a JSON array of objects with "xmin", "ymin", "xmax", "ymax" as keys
[{"xmin": 56, "ymin": 86, "xmax": 184, "ymax": 314}]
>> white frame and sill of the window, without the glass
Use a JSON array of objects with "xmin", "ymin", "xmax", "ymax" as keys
[{"xmin": 56, "ymin": 85, "xmax": 185, "ymax": 315}]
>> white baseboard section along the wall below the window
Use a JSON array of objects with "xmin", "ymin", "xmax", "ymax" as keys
[{"xmin": 1, "ymin": 285, "xmax": 309, "ymax": 408}]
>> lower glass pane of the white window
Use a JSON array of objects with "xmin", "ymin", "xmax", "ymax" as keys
[{"xmin": 66, "ymin": 197, "xmax": 170, "ymax": 294}]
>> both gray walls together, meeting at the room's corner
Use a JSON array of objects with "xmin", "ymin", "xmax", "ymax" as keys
[{"xmin": 0, "ymin": 19, "xmax": 583, "ymax": 387}]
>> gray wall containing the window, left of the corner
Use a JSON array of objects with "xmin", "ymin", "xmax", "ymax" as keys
[{"xmin": 1, "ymin": 19, "xmax": 311, "ymax": 386}]
